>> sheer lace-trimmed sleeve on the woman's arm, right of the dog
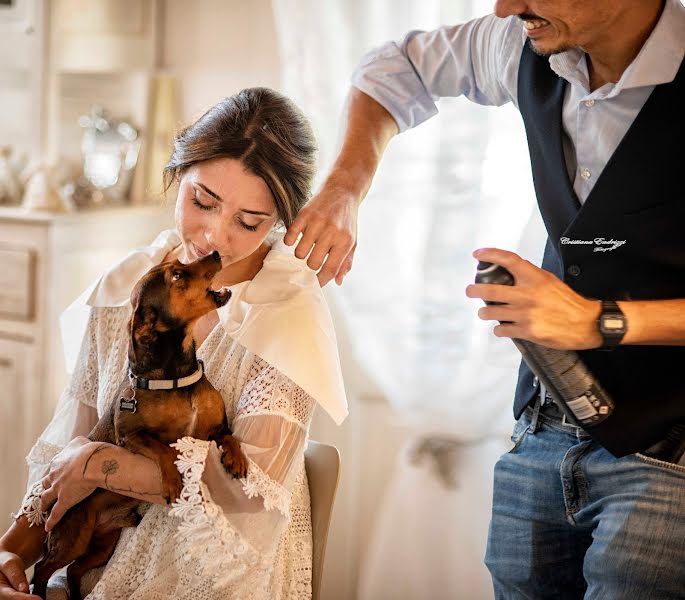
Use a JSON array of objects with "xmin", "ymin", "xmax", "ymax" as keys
[{"xmin": 171, "ymin": 358, "xmax": 314, "ymax": 584}]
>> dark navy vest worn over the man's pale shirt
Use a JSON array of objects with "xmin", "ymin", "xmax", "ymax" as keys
[{"xmin": 514, "ymin": 44, "xmax": 685, "ymax": 456}]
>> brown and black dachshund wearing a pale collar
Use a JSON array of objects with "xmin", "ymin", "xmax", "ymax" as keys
[{"xmin": 33, "ymin": 252, "xmax": 247, "ymax": 600}]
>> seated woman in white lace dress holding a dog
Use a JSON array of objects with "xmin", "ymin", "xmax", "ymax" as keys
[{"xmin": 0, "ymin": 88, "xmax": 347, "ymax": 600}]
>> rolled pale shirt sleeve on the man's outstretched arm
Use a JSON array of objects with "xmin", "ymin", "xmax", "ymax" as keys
[{"xmin": 352, "ymin": 15, "xmax": 525, "ymax": 131}]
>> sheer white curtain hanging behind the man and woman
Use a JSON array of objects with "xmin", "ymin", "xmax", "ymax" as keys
[{"xmin": 273, "ymin": 0, "xmax": 545, "ymax": 600}]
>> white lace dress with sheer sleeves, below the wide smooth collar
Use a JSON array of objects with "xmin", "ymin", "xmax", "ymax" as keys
[{"xmin": 14, "ymin": 231, "xmax": 348, "ymax": 600}]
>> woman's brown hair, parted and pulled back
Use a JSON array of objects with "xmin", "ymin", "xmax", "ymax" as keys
[{"xmin": 164, "ymin": 87, "xmax": 316, "ymax": 227}]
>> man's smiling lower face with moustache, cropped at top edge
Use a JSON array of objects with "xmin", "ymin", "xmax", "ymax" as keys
[{"xmin": 495, "ymin": 0, "xmax": 622, "ymax": 55}]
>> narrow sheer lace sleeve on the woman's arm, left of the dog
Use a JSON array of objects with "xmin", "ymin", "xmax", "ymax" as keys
[{"xmin": 13, "ymin": 309, "xmax": 98, "ymax": 525}]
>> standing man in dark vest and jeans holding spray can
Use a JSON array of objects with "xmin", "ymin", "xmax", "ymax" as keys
[{"xmin": 286, "ymin": 0, "xmax": 685, "ymax": 600}]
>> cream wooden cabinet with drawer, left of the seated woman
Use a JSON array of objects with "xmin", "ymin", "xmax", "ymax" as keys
[{"xmin": 0, "ymin": 207, "xmax": 173, "ymax": 529}]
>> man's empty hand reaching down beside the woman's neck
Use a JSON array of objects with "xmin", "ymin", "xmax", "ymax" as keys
[{"xmin": 283, "ymin": 179, "xmax": 360, "ymax": 287}]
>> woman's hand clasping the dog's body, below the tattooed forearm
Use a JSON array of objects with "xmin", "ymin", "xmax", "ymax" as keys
[{"xmin": 40, "ymin": 437, "xmax": 109, "ymax": 531}]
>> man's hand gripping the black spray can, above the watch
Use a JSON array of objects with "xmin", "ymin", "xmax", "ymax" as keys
[{"xmin": 466, "ymin": 248, "xmax": 602, "ymax": 350}]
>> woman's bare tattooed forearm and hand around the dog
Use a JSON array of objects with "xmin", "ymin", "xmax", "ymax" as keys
[{"xmin": 41, "ymin": 437, "xmax": 167, "ymax": 531}]
